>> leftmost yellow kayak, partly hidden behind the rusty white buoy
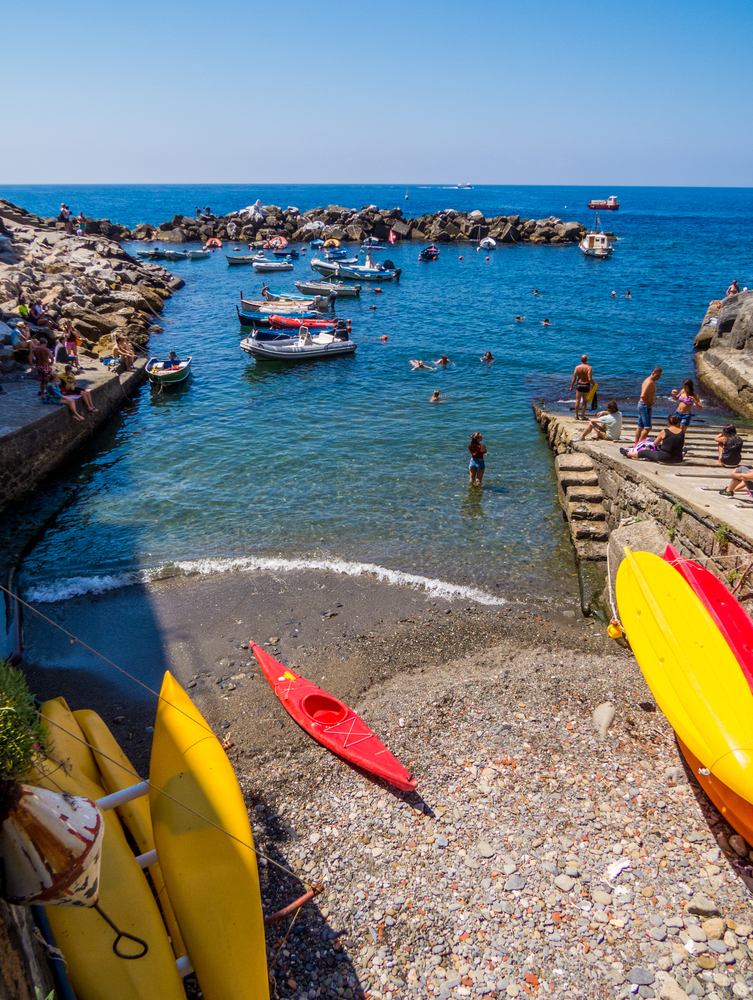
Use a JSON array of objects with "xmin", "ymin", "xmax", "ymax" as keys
[{"xmin": 31, "ymin": 698, "xmax": 186, "ymax": 1000}]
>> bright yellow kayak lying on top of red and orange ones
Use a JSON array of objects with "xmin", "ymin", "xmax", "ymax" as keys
[{"xmin": 616, "ymin": 549, "xmax": 753, "ymax": 801}]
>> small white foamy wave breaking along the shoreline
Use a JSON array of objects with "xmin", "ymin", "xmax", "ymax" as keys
[{"xmin": 25, "ymin": 556, "xmax": 507, "ymax": 605}]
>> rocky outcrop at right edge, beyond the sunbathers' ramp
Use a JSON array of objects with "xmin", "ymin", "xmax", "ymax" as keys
[{"xmin": 695, "ymin": 291, "xmax": 753, "ymax": 420}]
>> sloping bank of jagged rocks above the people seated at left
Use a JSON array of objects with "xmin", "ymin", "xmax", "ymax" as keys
[{"xmin": 0, "ymin": 200, "xmax": 183, "ymax": 353}]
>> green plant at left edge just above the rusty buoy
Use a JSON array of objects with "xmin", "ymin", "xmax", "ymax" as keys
[{"xmin": 0, "ymin": 660, "xmax": 47, "ymax": 781}]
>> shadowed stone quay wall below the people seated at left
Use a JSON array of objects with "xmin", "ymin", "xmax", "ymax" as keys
[{"xmin": 0, "ymin": 359, "xmax": 146, "ymax": 509}]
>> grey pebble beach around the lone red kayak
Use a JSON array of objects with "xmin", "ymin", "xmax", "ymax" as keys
[{"xmin": 26, "ymin": 572, "xmax": 753, "ymax": 1000}]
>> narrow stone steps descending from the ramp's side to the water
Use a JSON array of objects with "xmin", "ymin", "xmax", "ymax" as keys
[{"xmin": 554, "ymin": 452, "xmax": 609, "ymax": 562}]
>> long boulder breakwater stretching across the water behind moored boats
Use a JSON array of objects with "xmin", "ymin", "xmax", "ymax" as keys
[{"xmin": 0, "ymin": 201, "xmax": 586, "ymax": 244}]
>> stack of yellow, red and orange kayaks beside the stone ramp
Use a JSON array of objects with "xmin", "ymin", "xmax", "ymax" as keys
[{"xmin": 616, "ymin": 549, "xmax": 753, "ymax": 841}]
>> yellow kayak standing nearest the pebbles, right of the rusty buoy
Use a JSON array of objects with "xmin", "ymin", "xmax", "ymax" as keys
[{"xmin": 149, "ymin": 672, "xmax": 269, "ymax": 1000}]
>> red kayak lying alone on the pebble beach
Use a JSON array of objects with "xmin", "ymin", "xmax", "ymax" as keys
[{"xmin": 250, "ymin": 642, "xmax": 418, "ymax": 792}]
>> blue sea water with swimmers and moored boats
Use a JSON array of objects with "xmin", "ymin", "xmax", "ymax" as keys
[{"xmin": 5, "ymin": 185, "xmax": 753, "ymax": 599}]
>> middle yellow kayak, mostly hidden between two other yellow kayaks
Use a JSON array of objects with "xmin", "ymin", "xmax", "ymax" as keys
[{"xmin": 73, "ymin": 709, "xmax": 186, "ymax": 957}]
